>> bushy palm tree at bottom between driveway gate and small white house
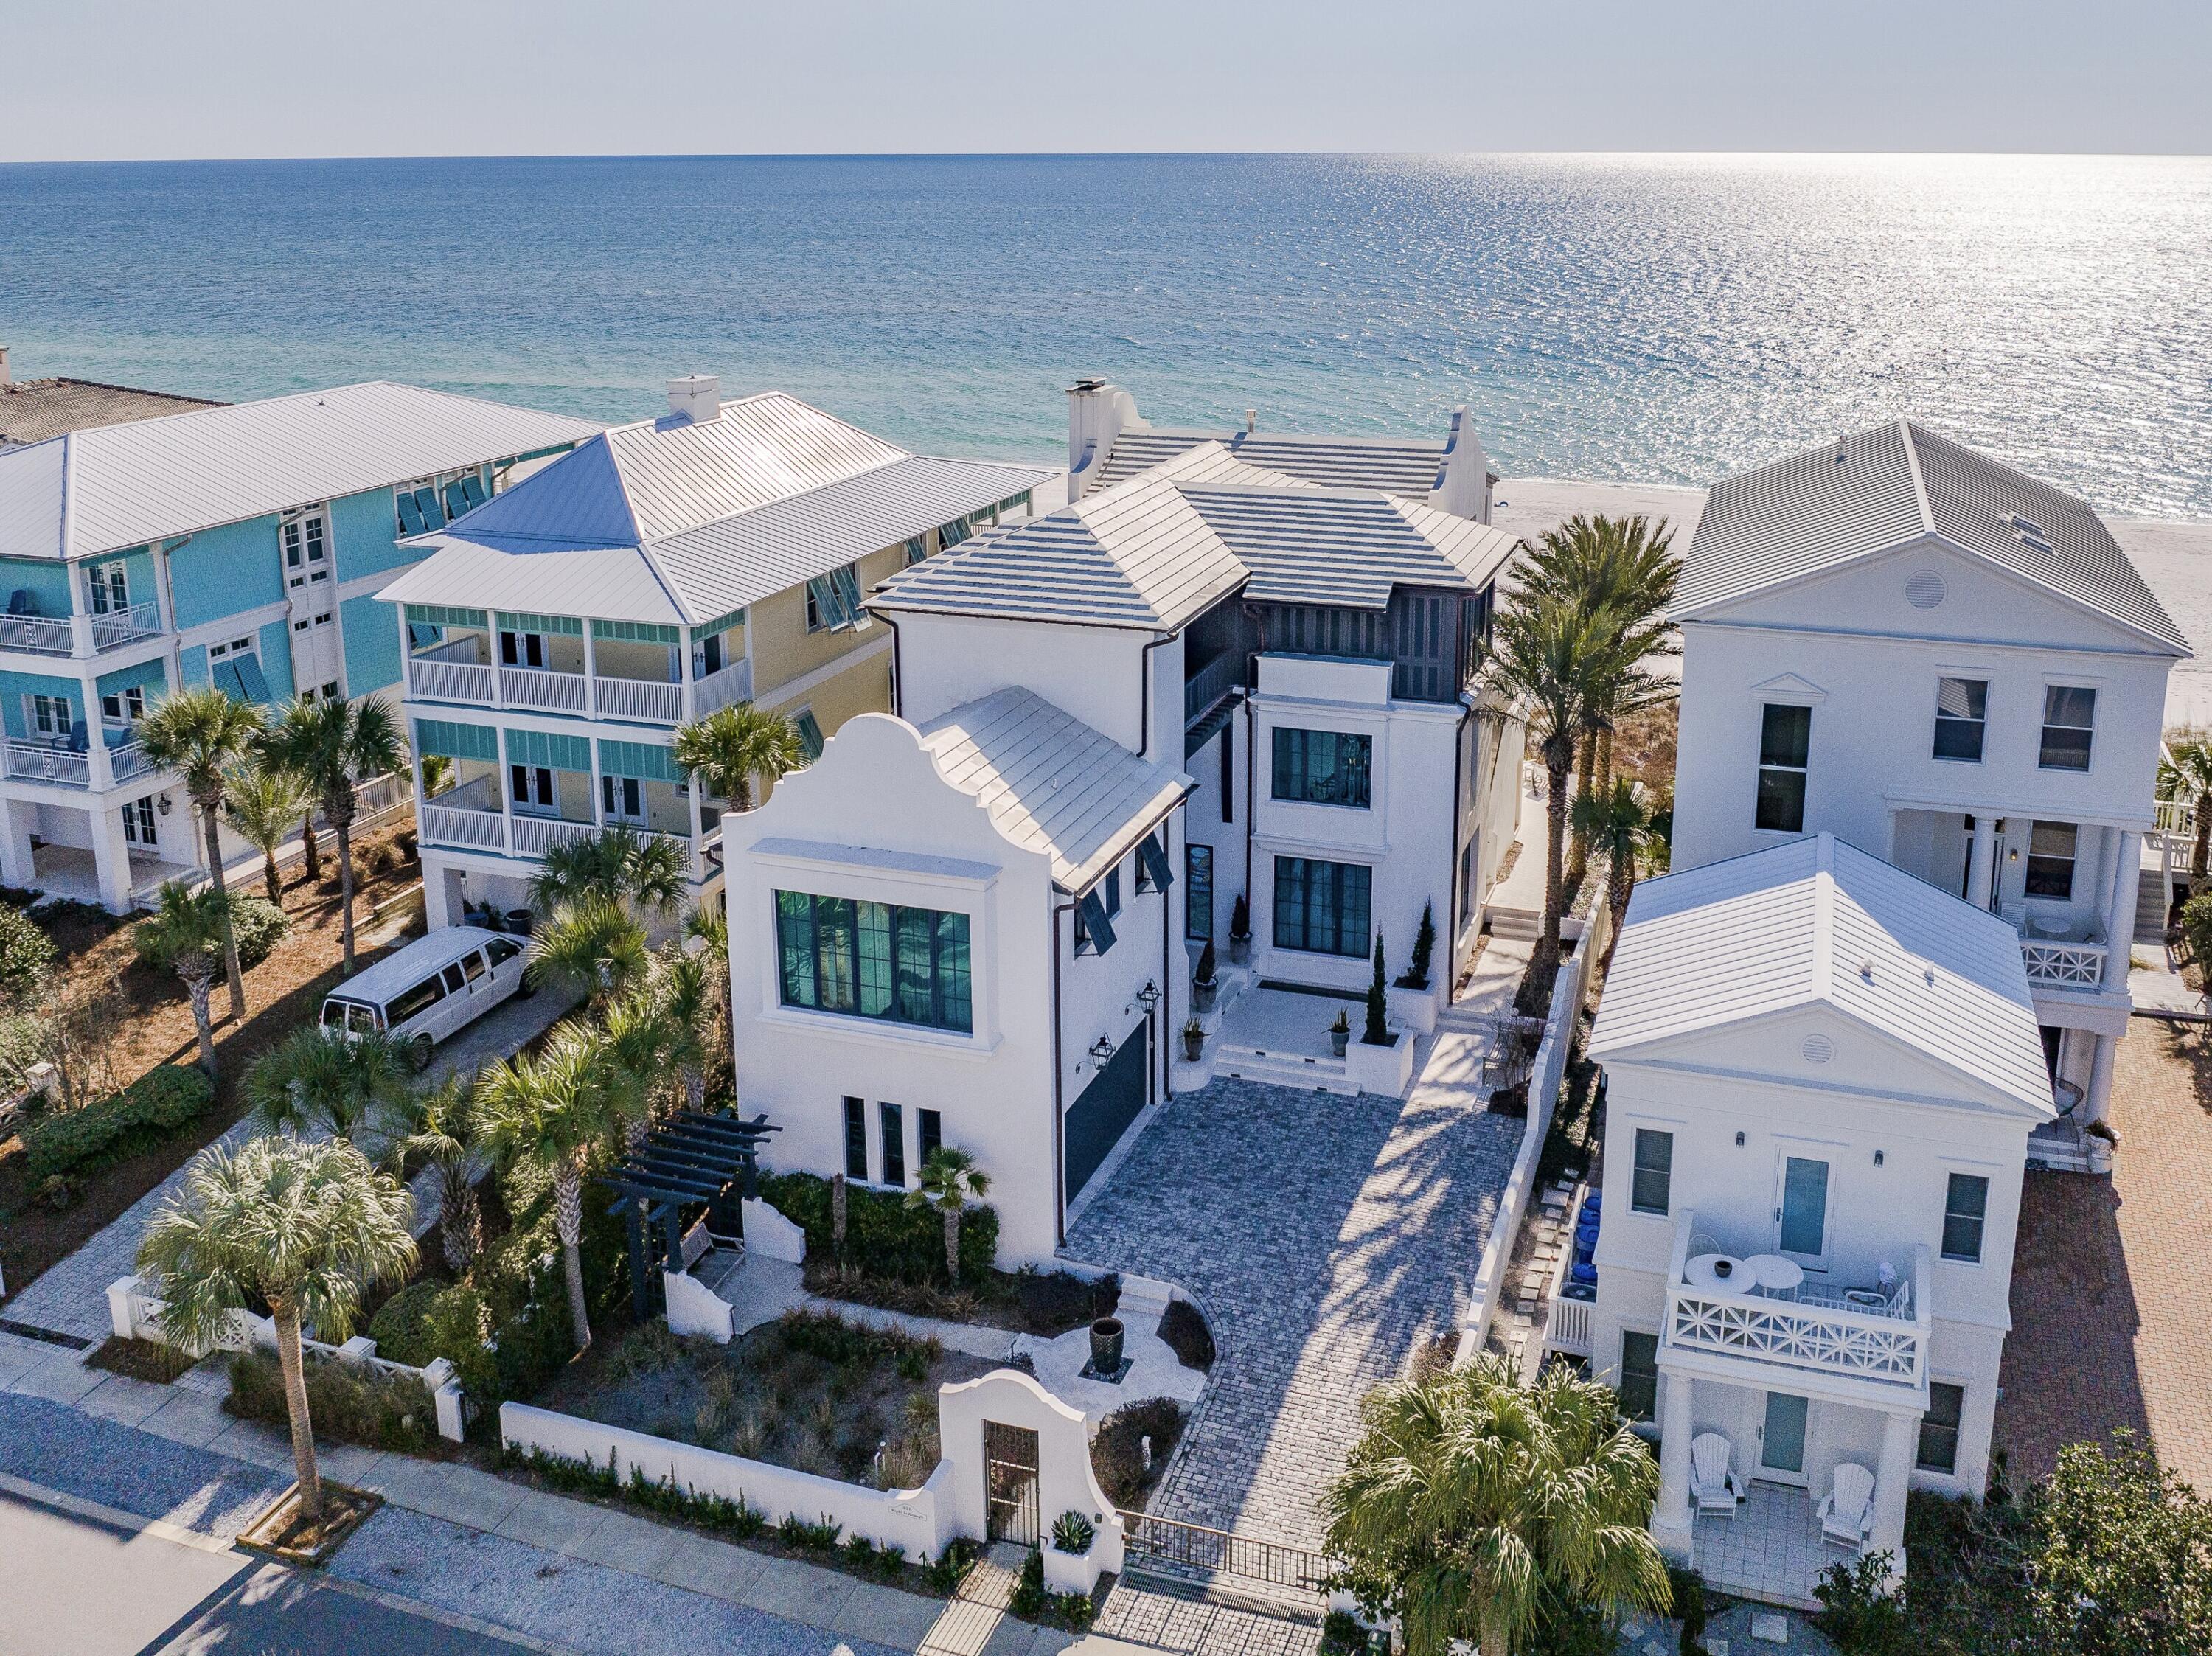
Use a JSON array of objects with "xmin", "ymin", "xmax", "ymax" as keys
[{"xmin": 1323, "ymin": 1357, "xmax": 1672, "ymax": 1656}]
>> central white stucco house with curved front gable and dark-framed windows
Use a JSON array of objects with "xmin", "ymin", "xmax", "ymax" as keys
[{"xmin": 721, "ymin": 387, "xmax": 1522, "ymax": 1264}]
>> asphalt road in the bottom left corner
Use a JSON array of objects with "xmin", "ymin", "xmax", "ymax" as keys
[{"xmin": 0, "ymin": 1492, "xmax": 546, "ymax": 1656}]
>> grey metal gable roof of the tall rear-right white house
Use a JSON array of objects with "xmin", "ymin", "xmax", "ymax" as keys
[{"xmin": 1674, "ymin": 420, "xmax": 2190, "ymax": 657}]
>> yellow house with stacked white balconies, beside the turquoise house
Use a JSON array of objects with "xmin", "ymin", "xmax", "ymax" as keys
[{"xmin": 378, "ymin": 374, "xmax": 1051, "ymax": 926}]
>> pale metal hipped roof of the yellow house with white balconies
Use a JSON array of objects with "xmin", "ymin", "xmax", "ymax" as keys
[{"xmin": 380, "ymin": 392, "xmax": 1053, "ymax": 624}]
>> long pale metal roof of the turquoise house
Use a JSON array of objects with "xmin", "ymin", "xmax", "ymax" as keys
[{"xmin": 0, "ymin": 380, "xmax": 599, "ymax": 560}]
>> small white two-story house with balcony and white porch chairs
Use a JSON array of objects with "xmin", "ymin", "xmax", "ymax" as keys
[{"xmin": 1590, "ymin": 831, "xmax": 2053, "ymax": 1603}]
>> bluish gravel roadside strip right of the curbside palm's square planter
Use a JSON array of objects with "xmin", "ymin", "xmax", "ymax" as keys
[{"xmin": 330, "ymin": 1506, "xmax": 898, "ymax": 1656}]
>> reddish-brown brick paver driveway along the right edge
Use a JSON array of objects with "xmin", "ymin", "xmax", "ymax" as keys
[{"xmin": 1997, "ymin": 1017, "xmax": 2212, "ymax": 1492}]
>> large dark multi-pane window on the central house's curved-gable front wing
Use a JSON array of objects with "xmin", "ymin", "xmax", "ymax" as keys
[{"xmin": 776, "ymin": 891, "xmax": 973, "ymax": 1034}]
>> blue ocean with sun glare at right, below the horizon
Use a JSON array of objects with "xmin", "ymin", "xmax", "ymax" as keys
[{"xmin": 0, "ymin": 155, "xmax": 2212, "ymax": 518}]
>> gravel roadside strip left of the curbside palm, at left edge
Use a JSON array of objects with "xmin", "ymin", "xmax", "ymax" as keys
[{"xmin": 0, "ymin": 1393, "xmax": 290, "ymax": 1541}]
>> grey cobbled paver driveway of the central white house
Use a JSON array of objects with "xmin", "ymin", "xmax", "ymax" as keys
[{"xmin": 1066, "ymin": 1052, "xmax": 1522, "ymax": 1548}]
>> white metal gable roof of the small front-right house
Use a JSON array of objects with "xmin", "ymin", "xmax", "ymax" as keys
[{"xmin": 1590, "ymin": 833, "xmax": 2053, "ymax": 1116}]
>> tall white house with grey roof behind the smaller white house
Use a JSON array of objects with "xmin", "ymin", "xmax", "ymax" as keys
[{"xmin": 1674, "ymin": 422, "xmax": 2190, "ymax": 1165}]
